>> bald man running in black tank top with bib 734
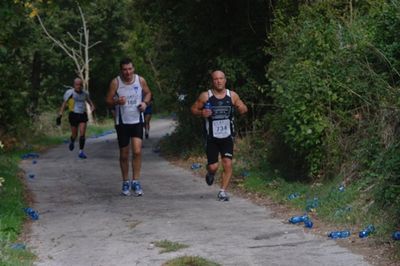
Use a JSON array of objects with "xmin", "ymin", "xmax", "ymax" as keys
[{"xmin": 191, "ymin": 70, "xmax": 247, "ymax": 201}]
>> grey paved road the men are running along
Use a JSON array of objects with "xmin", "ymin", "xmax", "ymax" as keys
[{"xmin": 22, "ymin": 119, "xmax": 368, "ymax": 266}]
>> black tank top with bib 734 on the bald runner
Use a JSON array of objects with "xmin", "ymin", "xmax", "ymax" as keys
[{"xmin": 204, "ymin": 90, "xmax": 234, "ymax": 139}]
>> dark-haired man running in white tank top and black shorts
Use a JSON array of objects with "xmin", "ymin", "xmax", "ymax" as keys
[{"xmin": 106, "ymin": 58, "xmax": 151, "ymax": 196}]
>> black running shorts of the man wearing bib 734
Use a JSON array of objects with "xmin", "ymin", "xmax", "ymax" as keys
[{"xmin": 206, "ymin": 137, "xmax": 233, "ymax": 164}]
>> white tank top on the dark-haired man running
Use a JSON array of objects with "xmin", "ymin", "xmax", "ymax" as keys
[{"xmin": 115, "ymin": 75, "xmax": 144, "ymax": 125}]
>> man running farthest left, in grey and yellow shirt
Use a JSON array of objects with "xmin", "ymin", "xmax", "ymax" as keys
[{"xmin": 56, "ymin": 78, "xmax": 95, "ymax": 159}]
